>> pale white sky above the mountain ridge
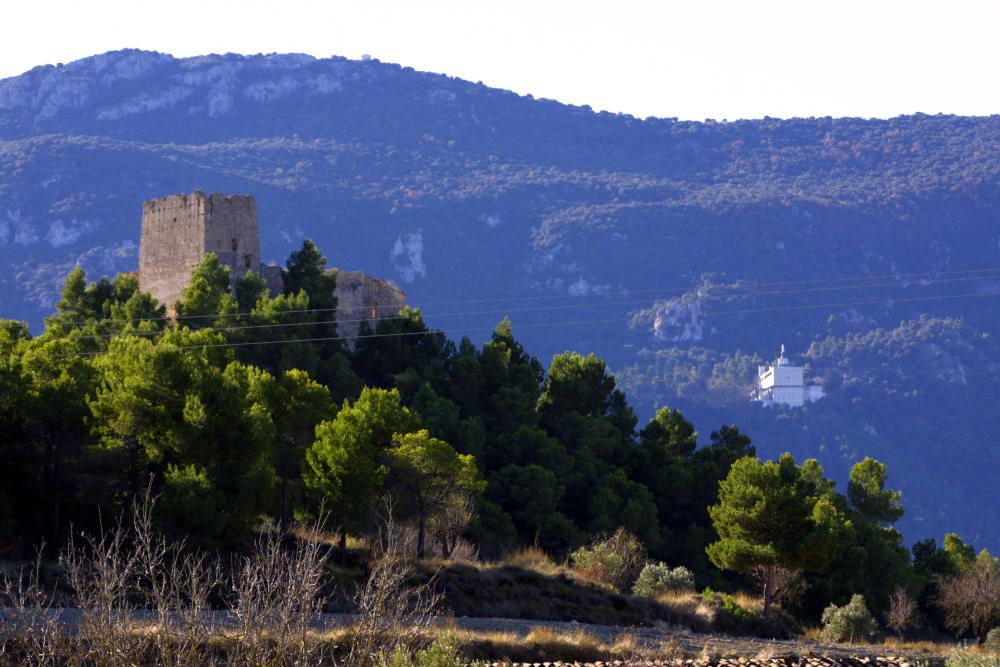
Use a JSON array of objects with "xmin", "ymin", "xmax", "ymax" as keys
[{"xmin": 0, "ymin": 0, "xmax": 1000, "ymax": 120}]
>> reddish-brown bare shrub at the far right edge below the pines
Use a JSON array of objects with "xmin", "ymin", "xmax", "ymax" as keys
[{"xmin": 935, "ymin": 556, "xmax": 1000, "ymax": 643}]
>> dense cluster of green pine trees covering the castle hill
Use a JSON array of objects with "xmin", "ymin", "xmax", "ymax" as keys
[{"xmin": 0, "ymin": 242, "xmax": 998, "ymax": 636}]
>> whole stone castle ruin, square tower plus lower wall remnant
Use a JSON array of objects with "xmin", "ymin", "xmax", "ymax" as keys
[{"xmin": 139, "ymin": 191, "xmax": 406, "ymax": 337}]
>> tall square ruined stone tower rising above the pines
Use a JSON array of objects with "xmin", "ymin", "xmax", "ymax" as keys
[{"xmin": 139, "ymin": 191, "xmax": 260, "ymax": 308}]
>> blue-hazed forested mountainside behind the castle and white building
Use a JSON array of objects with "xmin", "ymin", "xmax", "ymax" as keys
[{"xmin": 0, "ymin": 51, "xmax": 1000, "ymax": 550}]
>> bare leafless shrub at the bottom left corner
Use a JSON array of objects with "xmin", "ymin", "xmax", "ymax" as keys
[{"xmin": 0, "ymin": 548, "xmax": 73, "ymax": 665}]
